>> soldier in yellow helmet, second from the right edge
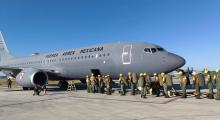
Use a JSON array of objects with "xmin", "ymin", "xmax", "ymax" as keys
[{"xmin": 204, "ymin": 69, "xmax": 214, "ymax": 99}]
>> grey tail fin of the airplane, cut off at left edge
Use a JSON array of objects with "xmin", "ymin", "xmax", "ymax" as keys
[{"xmin": 0, "ymin": 32, "xmax": 14, "ymax": 62}]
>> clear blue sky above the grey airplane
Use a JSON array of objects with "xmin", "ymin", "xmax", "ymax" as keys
[{"xmin": 0, "ymin": 0, "xmax": 220, "ymax": 70}]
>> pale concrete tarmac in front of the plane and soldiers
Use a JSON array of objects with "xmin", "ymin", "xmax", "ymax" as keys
[{"xmin": 0, "ymin": 86, "xmax": 220, "ymax": 120}]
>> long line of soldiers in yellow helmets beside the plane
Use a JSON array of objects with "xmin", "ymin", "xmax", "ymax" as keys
[{"xmin": 86, "ymin": 69, "xmax": 220, "ymax": 100}]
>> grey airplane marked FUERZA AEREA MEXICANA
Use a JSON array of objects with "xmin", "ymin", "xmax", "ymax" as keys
[{"xmin": 0, "ymin": 32, "xmax": 186, "ymax": 90}]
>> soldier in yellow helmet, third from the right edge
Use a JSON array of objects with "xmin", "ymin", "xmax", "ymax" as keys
[{"xmin": 192, "ymin": 72, "xmax": 200, "ymax": 99}]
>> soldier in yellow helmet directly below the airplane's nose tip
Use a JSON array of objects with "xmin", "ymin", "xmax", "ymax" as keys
[{"xmin": 178, "ymin": 70, "xmax": 187, "ymax": 98}]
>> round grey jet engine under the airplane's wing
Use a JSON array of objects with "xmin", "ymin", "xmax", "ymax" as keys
[{"xmin": 16, "ymin": 68, "xmax": 48, "ymax": 88}]
